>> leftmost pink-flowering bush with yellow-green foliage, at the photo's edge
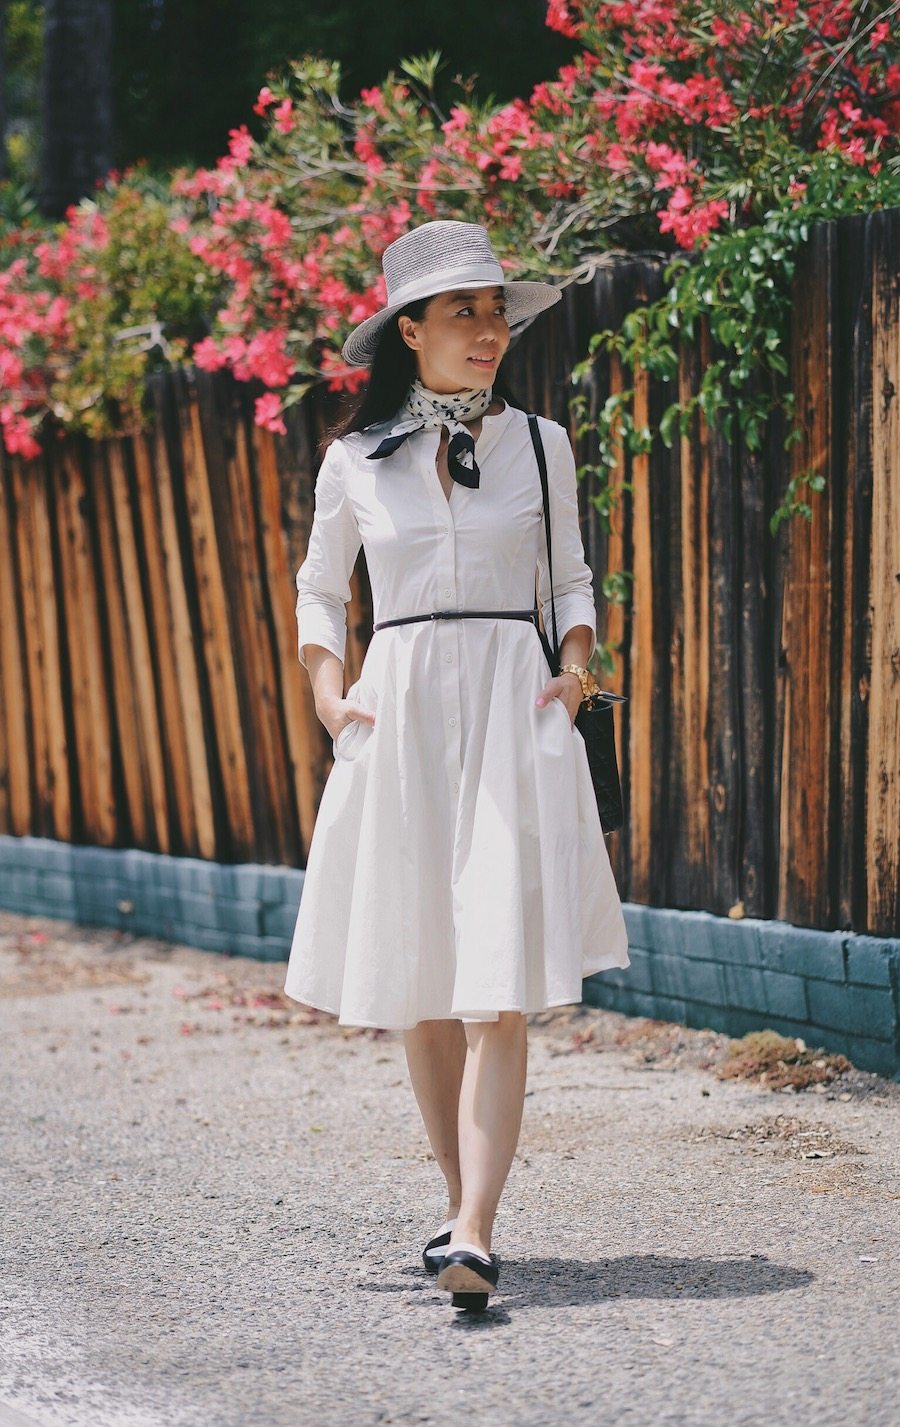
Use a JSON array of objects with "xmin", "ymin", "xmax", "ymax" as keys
[{"xmin": 0, "ymin": 166, "xmax": 221, "ymax": 457}]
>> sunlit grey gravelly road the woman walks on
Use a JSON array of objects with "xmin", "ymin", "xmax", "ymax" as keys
[{"xmin": 0, "ymin": 912, "xmax": 900, "ymax": 1427}]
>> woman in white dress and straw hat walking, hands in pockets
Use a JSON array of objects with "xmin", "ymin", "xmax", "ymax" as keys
[{"xmin": 285, "ymin": 221, "xmax": 629, "ymax": 1307}]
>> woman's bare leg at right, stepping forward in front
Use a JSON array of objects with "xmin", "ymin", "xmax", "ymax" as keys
[{"xmin": 448, "ymin": 1010, "xmax": 528, "ymax": 1253}]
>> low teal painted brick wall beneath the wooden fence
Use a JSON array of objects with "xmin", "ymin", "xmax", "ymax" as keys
[{"xmin": 0, "ymin": 836, "xmax": 900, "ymax": 1079}]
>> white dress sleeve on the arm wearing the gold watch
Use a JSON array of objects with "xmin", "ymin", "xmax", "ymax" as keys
[{"xmin": 538, "ymin": 421, "xmax": 596, "ymax": 644}]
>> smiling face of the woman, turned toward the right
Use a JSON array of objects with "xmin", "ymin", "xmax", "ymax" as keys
[{"xmin": 397, "ymin": 287, "xmax": 509, "ymax": 395}]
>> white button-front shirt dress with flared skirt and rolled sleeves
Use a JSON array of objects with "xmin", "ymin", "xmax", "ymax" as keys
[{"xmin": 284, "ymin": 404, "xmax": 630, "ymax": 1029}]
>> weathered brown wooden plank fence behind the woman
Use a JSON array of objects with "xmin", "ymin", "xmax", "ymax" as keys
[{"xmin": 0, "ymin": 210, "xmax": 900, "ymax": 935}]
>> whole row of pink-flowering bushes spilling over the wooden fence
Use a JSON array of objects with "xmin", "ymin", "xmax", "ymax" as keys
[{"xmin": 0, "ymin": 0, "xmax": 900, "ymax": 455}]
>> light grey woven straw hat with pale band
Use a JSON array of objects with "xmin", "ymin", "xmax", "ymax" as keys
[{"xmin": 341, "ymin": 220, "xmax": 562, "ymax": 367}]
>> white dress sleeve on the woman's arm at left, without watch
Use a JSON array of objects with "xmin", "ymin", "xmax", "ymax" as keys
[{"xmin": 297, "ymin": 441, "xmax": 362, "ymax": 668}]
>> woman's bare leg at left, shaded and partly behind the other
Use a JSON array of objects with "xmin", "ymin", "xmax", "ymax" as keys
[{"xmin": 404, "ymin": 1019, "xmax": 466, "ymax": 1219}]
